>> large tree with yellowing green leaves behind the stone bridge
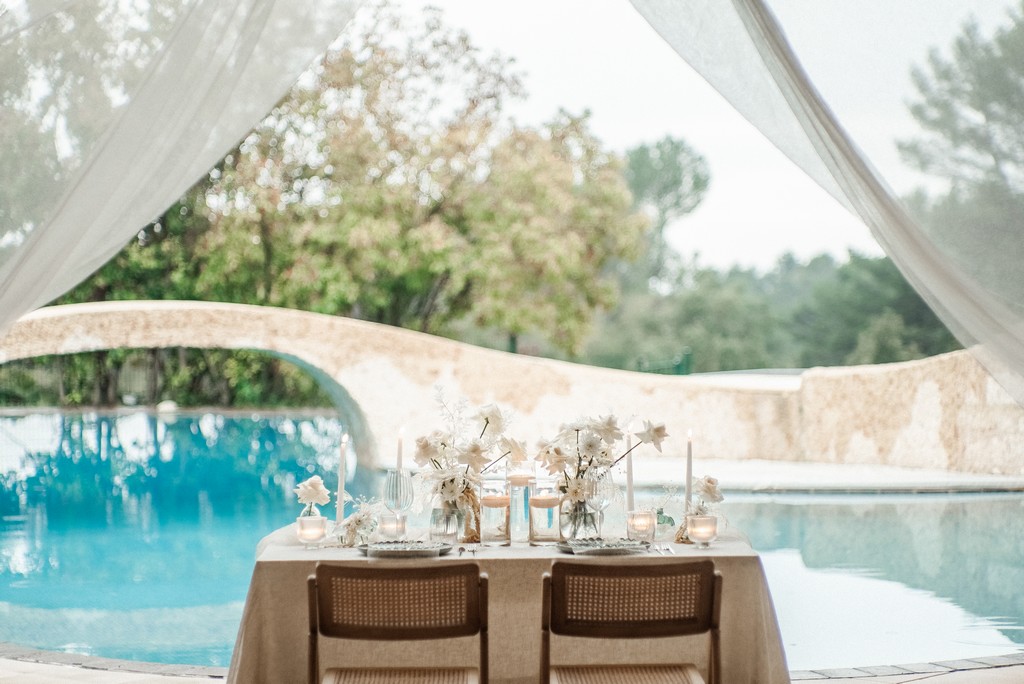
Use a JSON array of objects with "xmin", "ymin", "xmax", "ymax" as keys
[{"xmin": 200, "ymin": 0, "xmax": 644, "ymax": 353}]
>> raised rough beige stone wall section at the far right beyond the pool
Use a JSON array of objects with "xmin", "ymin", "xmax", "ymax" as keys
[{"xmin": 799, "ymin": 351, "xmax": 1024, "ymax": 475}]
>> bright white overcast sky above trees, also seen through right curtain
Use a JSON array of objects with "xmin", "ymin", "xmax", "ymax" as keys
[{"xmin": 409, "ymin": 0, "xmax": 1007, "ymax": 271}]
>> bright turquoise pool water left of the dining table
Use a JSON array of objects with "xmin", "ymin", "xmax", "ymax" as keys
[{"xmin": 0, "ymin": 413, "xmax": 373, "ymax": 666}]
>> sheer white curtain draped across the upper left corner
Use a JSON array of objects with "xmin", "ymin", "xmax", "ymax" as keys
[{"xmin": 0, "ymin": 0, "xmax": 358, "ymax": 334}]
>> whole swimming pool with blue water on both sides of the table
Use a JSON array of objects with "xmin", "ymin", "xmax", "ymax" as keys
[{"xmin": 0, "ymin": 412, "xmax": 1024, "ymax": 670}]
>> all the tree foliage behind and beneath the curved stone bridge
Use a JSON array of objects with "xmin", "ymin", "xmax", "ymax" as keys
[{"xmin": 6, "ymin": 3, "xmax": 966, "ymax": 405}]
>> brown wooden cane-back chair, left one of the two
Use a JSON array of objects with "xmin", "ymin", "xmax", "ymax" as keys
[{"xmin": 307, "ymin": 563, "xmax": 487, "ymax": 684}]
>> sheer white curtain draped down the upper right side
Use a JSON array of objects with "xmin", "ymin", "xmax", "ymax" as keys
[{"xmin": 632, "ymin": 0, "xmax": 1024, "ymax": 403}]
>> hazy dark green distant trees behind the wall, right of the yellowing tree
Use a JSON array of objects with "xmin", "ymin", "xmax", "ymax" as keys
[{"xmin": 587, "ymin": 248, "xmax": 959, "ymax": 372}]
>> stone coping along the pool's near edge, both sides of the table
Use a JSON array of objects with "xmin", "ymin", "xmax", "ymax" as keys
[{"xmin": 0, "ymin": 641, "xmax": 1024, "ymax": 682}]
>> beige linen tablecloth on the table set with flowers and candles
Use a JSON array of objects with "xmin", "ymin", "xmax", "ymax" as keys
[{"xmin": 227, "ymin": 525, "xmax": 790, "ymax": 684}]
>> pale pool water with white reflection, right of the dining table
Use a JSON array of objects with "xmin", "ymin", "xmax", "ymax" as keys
[{"xmin": 723, "ymin": 493, "xmax": 1024, "ymax": 670}]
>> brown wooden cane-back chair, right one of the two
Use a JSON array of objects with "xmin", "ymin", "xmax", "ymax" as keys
[{"xmin": 541, "ymin": 560, "xmax": 722, "ymax": 684}]
